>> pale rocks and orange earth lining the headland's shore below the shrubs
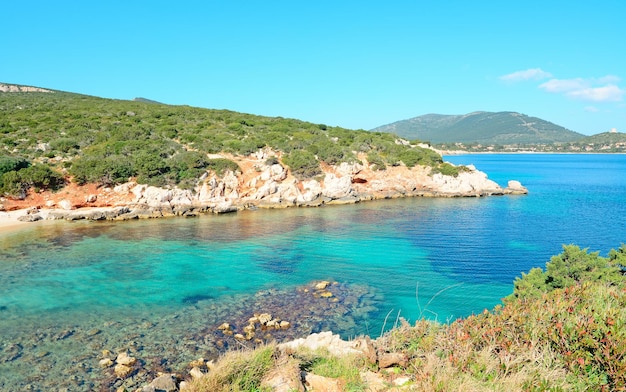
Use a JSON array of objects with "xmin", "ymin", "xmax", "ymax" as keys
[{"xmin": 12, "ymin": 150, "xmax": 528, "ymax": 221}]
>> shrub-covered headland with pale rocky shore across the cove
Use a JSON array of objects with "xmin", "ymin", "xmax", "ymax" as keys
[{"xmin": 0, "ymin": 85, "xmax": 522, "ymax": 214}]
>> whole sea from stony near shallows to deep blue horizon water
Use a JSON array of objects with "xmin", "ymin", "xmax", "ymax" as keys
[{"xmin": 0, "ymin": 154, "xmax": 626, "ymax": 391}]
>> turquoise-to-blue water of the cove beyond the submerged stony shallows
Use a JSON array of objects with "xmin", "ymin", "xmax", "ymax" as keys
[{"xmin": 0, "ymin": 154, "xmax": 626, "ymax": 386}]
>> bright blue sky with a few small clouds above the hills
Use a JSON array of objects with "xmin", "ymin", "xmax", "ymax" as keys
[{"xmin": 0, "ymin": 0, "xmax": 626, "ymax": 134}]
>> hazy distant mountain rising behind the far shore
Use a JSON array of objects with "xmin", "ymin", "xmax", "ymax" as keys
[{"xmin": 372, "ymin": 112, "xmax": 585, "ymax": 144}]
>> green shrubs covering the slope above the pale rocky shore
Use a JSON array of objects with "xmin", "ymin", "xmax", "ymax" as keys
[{"xmin": 0, "ymin": 88, "xmax": 441, "ymax": 195}]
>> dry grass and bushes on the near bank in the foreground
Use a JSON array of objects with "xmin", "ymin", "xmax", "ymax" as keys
[{"xmin": 185, "ymin": 245, "xmax": 626, "ymax": 391}]
